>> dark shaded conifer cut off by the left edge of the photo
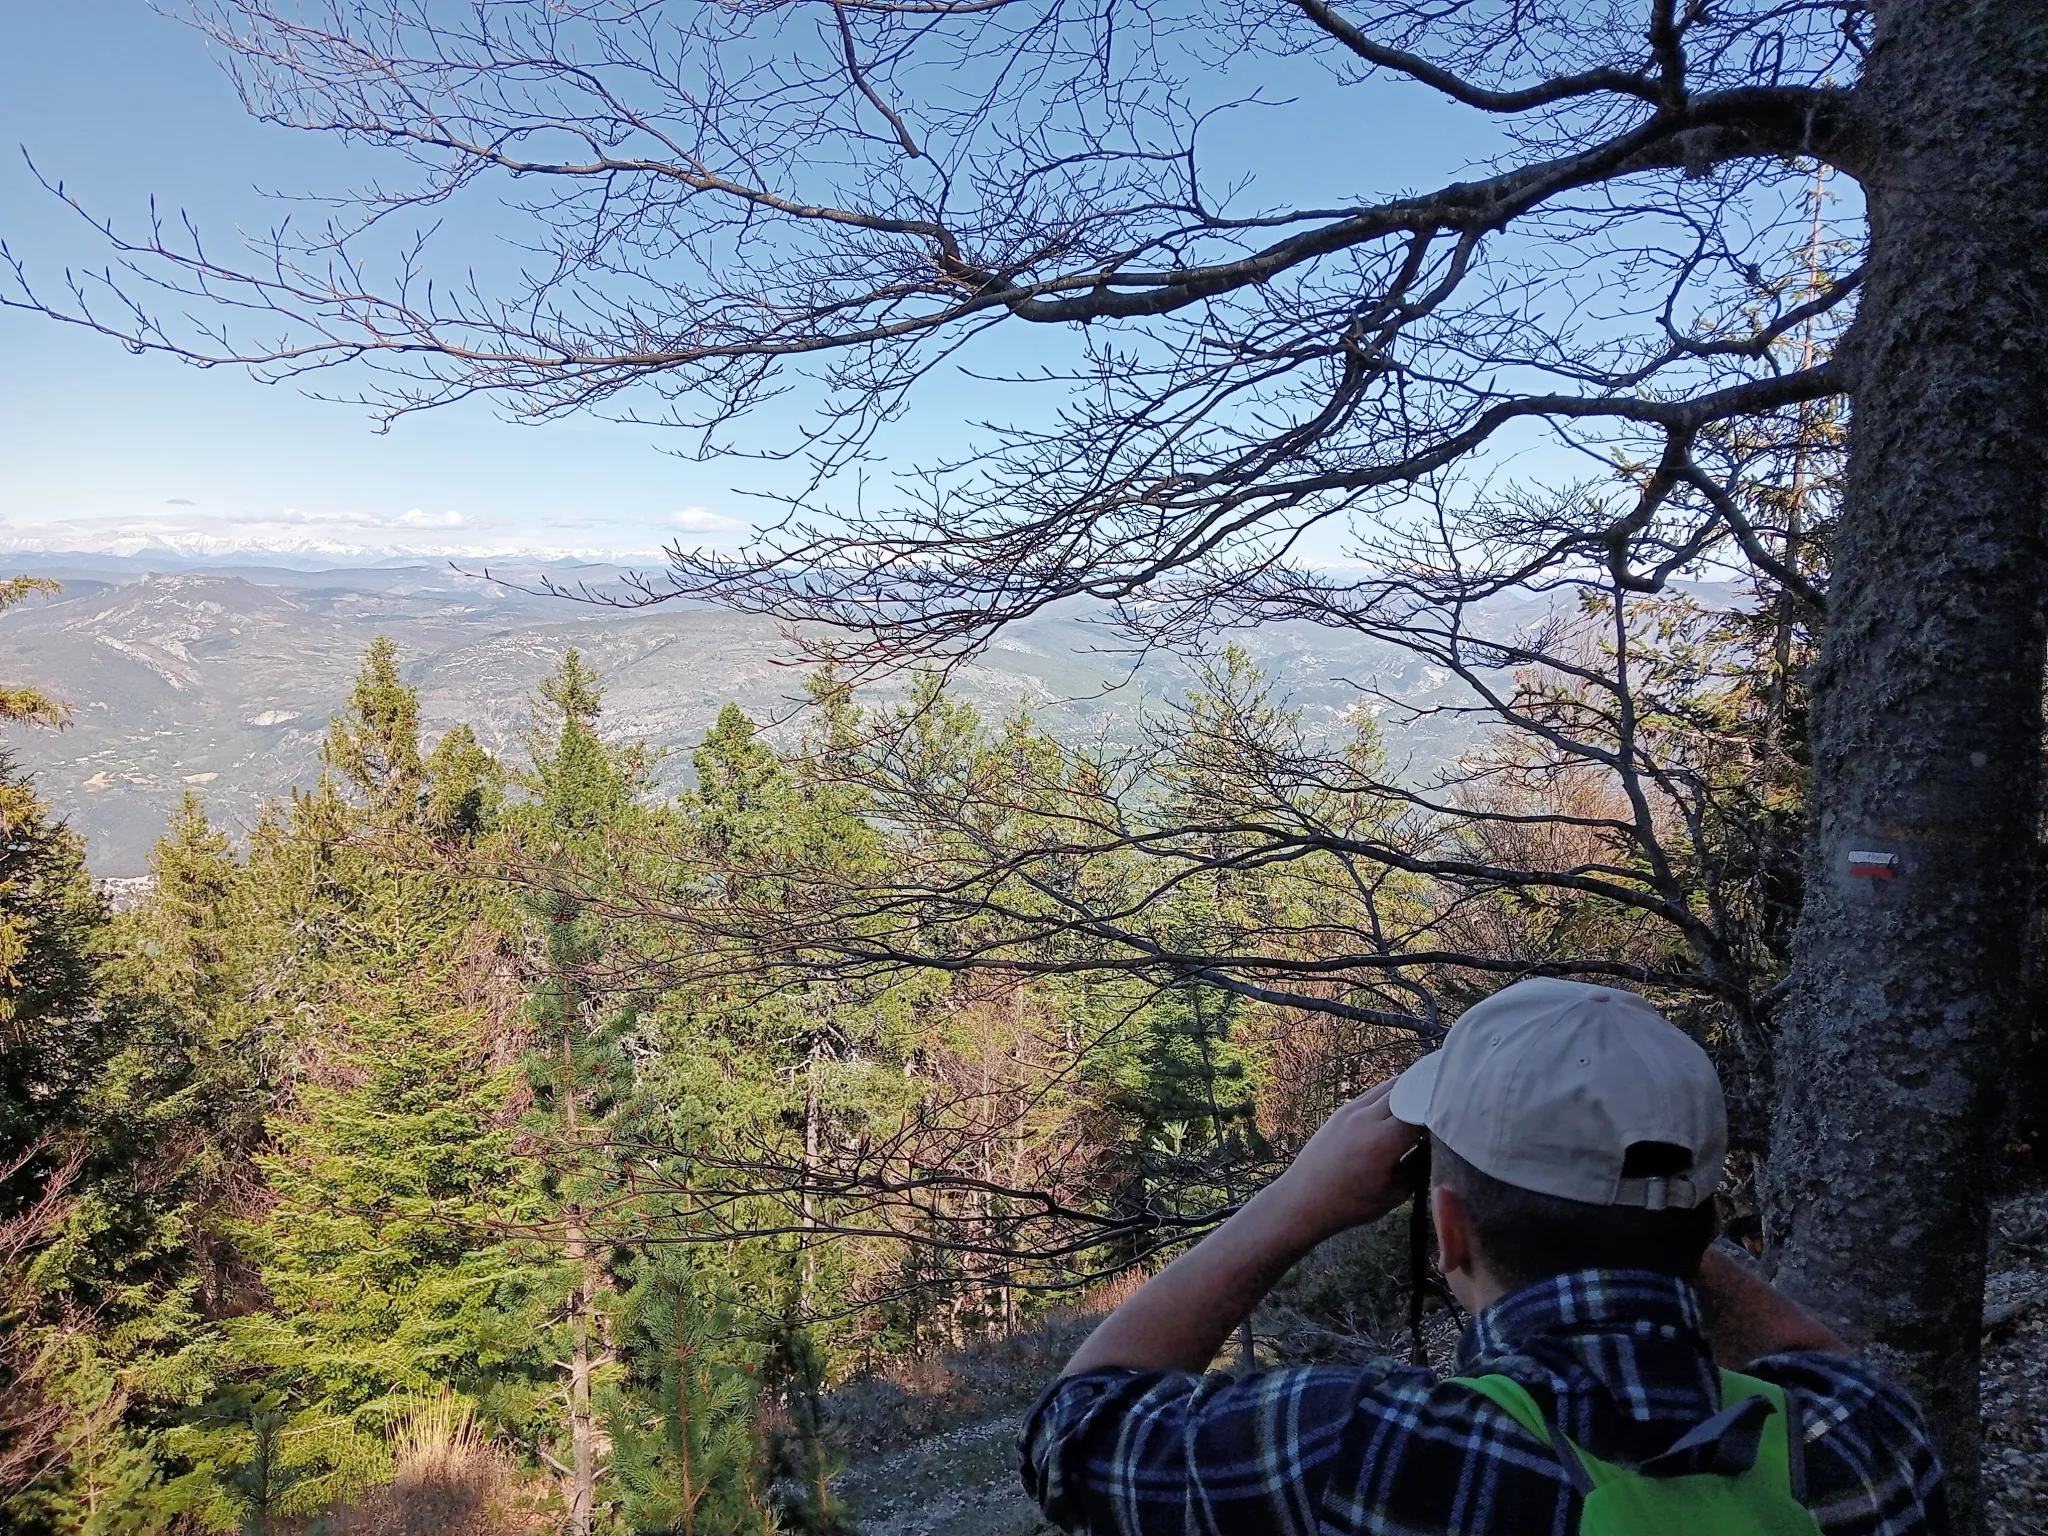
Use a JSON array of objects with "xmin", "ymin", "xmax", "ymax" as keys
[{"xmin": 0, "ymin": 634, "xmax": 232, "ymax": 1532}]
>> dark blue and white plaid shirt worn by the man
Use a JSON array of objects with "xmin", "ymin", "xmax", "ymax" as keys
[{"xmin": 1022, "ymin": 1270, "xmax": 1948, "ymax": 1536}]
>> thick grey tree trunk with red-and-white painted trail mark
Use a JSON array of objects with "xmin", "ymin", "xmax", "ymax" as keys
[{"xmin": 1765, "ymin": 0, "xmax": 2048, "ymax": 1530}]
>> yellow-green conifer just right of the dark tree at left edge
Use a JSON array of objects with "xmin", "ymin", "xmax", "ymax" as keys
[{"xmin": 25, "ymin": 795, "xmax": 281, "ymax": 1536}]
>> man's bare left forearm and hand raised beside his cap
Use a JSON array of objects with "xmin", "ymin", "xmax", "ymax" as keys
[{"xmin": 1063, "ymin": 1081, "xmax": 1423, "ymax": 1376}]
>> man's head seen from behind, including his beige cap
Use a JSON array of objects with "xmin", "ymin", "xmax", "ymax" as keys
[{"xmin": 1389, "ymin": 979, "xmax": 1729, "ymax": 1307}]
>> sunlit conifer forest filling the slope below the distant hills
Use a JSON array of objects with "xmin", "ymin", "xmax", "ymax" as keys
[{"xmin": 12, "ymin": 548, "xmax": 2040, "ymax": 1536}]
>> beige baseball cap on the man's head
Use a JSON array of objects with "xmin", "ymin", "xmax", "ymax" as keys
[{"xmin": 1386, "ymin": 977, "xmax": 1729, "ymax": 1210}]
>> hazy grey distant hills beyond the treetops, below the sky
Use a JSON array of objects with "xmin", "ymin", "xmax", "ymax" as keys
[{"xmin": 0, "ymin": 555, "xmax": 1507, "ymax": 877}]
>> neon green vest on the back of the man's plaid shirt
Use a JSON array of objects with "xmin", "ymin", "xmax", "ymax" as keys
[{"xmin": 1454, "ymin": 1370, "xmax": 1821, "ymax": 1536}]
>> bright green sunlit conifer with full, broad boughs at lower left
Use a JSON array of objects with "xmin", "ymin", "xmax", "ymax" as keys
[{"xmin": 225, "ymin": 950, "xmax": 528, "ymax": 1513}]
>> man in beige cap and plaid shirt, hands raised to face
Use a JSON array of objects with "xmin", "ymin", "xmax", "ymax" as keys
[{"xmin": 1024, "ymin": 981, "xmax": 1948, "ymax": 1536}]
